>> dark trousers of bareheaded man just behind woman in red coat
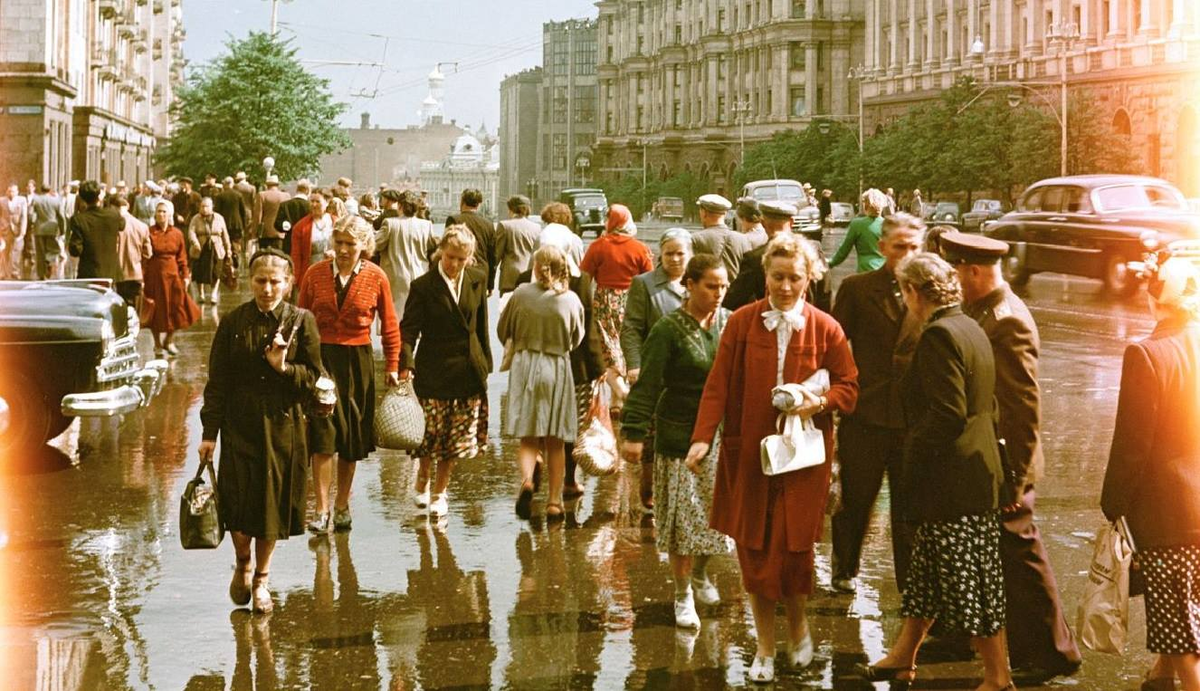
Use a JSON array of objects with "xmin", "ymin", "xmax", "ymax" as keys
[{"xmin": 833, "ymin": 417, "xmax": 917, "ymax": 591}]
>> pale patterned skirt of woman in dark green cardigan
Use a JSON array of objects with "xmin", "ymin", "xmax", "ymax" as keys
[{"xmin": 654, "ymin": 444, "xmax": 733, "ymax": 555}]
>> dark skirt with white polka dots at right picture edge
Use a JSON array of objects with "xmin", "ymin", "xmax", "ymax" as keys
[{"xmin": 1138, "ymin": 546, "xmax": 1200, "ymax": 655}]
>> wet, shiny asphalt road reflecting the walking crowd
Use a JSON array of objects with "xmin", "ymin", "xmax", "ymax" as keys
[{"xmin": 0, "ymin": 228, "xmax": 1152, "ymax": 691}]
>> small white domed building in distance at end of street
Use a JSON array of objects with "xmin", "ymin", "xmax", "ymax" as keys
[{"xmin": 419, "ymin": 127, "xmax": 503, "ymax": 220}]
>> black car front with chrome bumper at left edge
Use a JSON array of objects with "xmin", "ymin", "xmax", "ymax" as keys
[{"xmin": 0, "ymin": 280, "xmax": 167, "ymax": 449}]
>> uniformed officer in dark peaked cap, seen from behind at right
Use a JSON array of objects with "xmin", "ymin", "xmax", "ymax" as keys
[{"xmin": 941, "ymin": 232, "xmax": 1081, "ymax": 677}]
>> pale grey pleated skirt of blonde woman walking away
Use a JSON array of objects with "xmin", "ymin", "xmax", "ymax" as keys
[{"xmin": 504, "ymin": 350, "xmax": 578, "ymax": 441}]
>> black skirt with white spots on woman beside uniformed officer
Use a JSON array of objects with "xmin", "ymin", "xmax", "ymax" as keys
[{"xmin": 900, "ymin": 512, "xmax": 1004, "ymax": 638}]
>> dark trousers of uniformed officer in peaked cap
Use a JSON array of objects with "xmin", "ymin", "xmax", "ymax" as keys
[{"xmin": 1000, "ymin": 489, "xmax": 1081, "ymax": 671}]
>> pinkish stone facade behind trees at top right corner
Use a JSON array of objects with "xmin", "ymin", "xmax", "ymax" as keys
[{"xmin": 862, "ymin": 0, "xmax": 1200, "ymax": 197}]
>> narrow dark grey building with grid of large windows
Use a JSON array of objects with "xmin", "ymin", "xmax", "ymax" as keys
[{"xmin": 527, "ymin": 19, "xmax": 599, "ymax": 202}]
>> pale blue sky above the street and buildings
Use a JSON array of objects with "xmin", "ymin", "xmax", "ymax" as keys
[{"xmin": 184, "ymin": 0, "xmax": 596, "ymax": 132}]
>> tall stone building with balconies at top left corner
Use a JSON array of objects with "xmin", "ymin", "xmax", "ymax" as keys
[{"xmin": 0, "ymin": 0, "xmax": 185, "ymax": 186}]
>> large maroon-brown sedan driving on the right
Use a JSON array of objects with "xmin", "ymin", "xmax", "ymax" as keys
[{"xmin": 984, "ymin": 175, "xmax": 1200, "ymax": 296}]
